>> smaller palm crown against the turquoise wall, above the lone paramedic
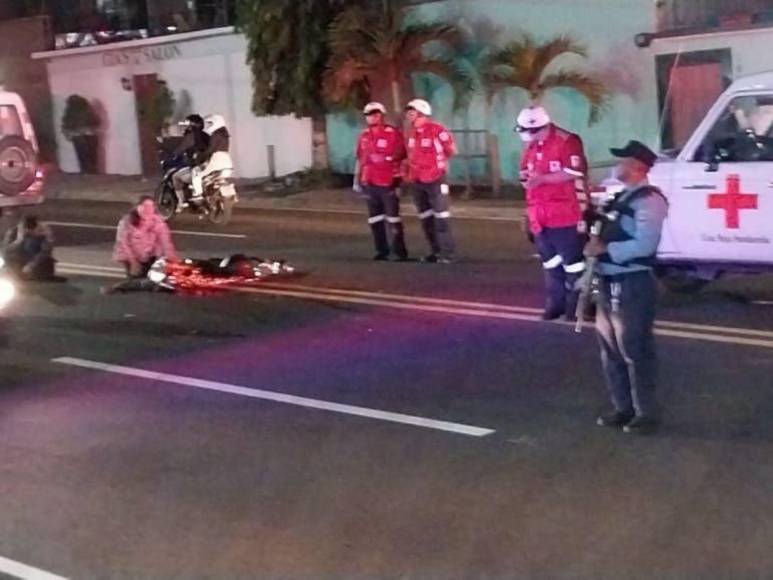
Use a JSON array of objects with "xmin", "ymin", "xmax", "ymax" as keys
[{"xmin": 482, "ymin": 34, "xmax": 611, "ymax": 125}]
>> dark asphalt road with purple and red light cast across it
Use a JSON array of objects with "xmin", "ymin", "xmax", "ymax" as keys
[{"xmin": 0, "ymin": 202, "xmax": 773, "ymax": 580}]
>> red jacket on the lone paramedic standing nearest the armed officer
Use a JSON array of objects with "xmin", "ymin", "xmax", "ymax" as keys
[{"xmin": 521, "ymin": 125, "xmax": 588, "ymax": 234}]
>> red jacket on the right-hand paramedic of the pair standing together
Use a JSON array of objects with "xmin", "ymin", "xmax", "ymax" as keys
[{"xmin": 408, "ymin": 121, "xmax": 456, "ymax": 183}]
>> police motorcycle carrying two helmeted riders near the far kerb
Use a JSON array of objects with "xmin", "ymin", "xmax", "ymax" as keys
[{"xmin": 154, "ymin": 152, "xmax": 238, "ymax": 225}]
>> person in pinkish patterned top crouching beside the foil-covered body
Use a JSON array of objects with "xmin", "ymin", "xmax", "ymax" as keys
[{"xmin": 102, "ymin": 195, "xmax": 179, "ymax": 294}]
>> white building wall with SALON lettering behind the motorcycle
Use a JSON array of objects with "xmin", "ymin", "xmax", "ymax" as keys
[{"xmin": 34, "ymin": 30, "xmax": 312, "ymax": 178}]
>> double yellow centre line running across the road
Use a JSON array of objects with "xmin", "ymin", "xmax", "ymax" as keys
[{"xmin": 55, "ymin": 264, "xmax": 773, "ymax": 349}]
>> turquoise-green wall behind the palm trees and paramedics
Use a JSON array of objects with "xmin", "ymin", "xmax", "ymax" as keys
[{"xmin": 328, "ymin": 0, "xmax": 658, "ymax": 181}]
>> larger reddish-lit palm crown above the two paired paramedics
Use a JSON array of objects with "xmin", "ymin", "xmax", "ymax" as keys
[{"xmin": 323, "ymin": 0, "xmax": 474, "ymax": 116}]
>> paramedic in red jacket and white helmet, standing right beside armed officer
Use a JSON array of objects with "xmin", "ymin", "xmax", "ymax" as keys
[{"xmin": 515, "ymin": 106, "xmax": 587, "ymax": 320}]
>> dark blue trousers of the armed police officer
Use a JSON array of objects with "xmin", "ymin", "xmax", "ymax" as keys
[{"xmin": 596, "ymin": 270, "xmax": 659, "ymax": 418}]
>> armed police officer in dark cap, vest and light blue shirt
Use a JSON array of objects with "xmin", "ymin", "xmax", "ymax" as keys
[{"xmin": 585, "ymin": 141, "xmax": 668, "ymax": 434}]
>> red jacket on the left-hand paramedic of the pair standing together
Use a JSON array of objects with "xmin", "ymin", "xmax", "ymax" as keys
[{"xmin": 355, "ymin": 125, "xmax": 405, "ymax": 187}]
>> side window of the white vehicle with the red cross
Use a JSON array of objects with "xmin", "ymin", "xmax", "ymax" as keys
[{"xmin": 694, "ymin": 95, "xmax": 773, "ymax": 162}]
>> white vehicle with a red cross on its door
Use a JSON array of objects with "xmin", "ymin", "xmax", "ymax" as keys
[{"xmin": 650, "ymin": 72, "xmax": 773, "ymax": 290}]
